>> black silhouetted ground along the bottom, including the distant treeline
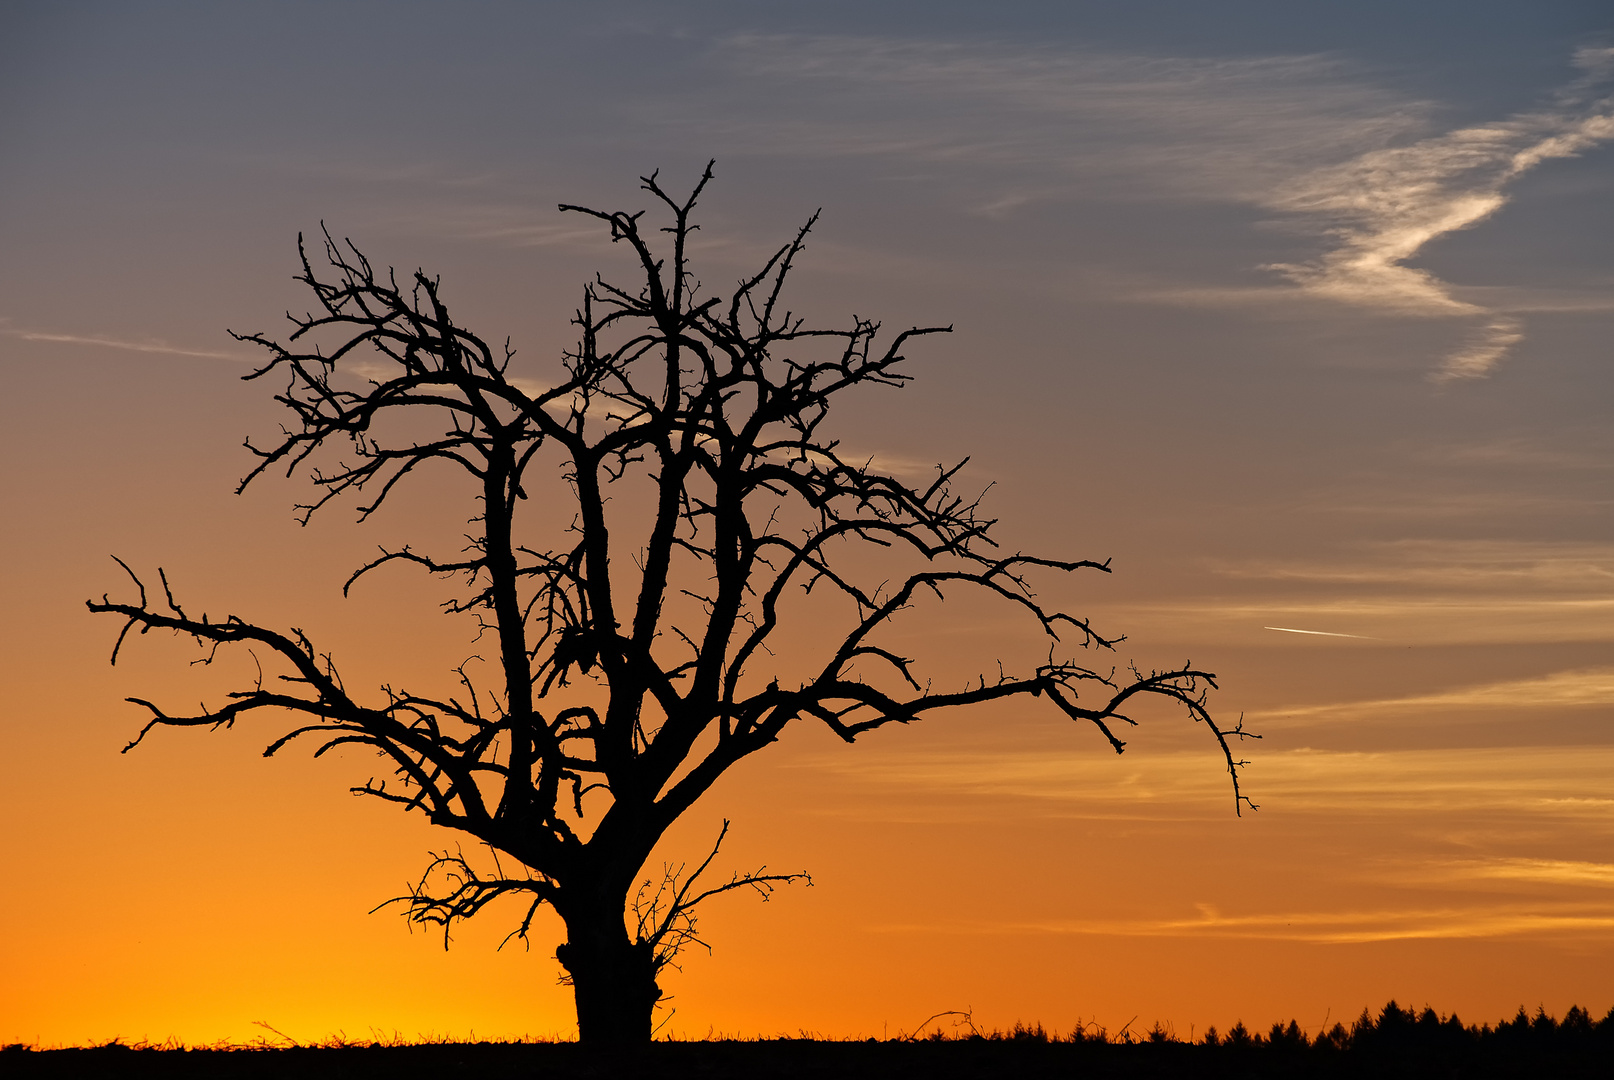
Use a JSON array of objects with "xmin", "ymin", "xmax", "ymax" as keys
[{"xmin": 12, "ymin": 1003, "xmax": 1614, "ymax": 1080}]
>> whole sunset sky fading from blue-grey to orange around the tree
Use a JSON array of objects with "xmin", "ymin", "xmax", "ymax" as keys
[{"xmin": 0, "ymin": 0, "xmax": 1614, "ymax": 1043}]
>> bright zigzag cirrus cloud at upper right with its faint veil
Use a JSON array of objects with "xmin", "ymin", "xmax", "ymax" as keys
[{"xmin": 718, "ymin": 34, "xmax": 1614, "ymax": 383}]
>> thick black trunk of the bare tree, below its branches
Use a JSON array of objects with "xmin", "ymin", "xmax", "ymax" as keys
[{"xmin": 555, "ymin": 909, "xmax": 662, "ymax": 1046}]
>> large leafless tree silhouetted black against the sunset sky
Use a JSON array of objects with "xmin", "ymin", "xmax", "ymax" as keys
[{"xmin": 89, "ymin": 166, "xmax": 1246, "ymax": 1044}]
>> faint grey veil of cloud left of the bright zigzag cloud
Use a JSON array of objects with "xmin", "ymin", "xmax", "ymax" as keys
[{"xmin": 713, "ymin": 34, "xmax": 1427, "ymax": 197}]
